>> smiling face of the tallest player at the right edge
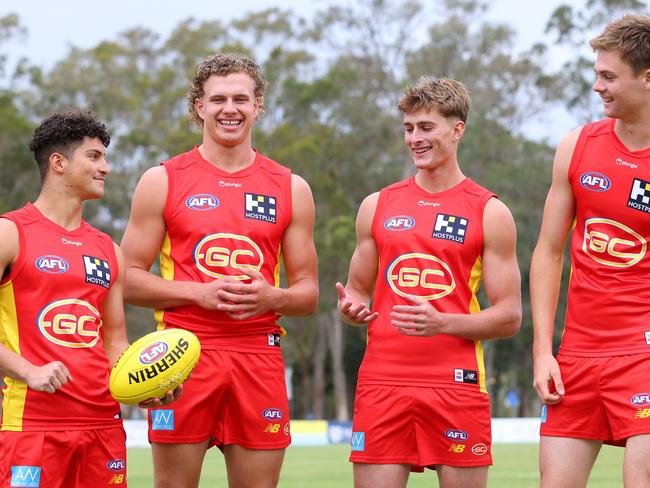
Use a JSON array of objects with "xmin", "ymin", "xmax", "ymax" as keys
[{"xmin": 592, "ymin": 50, "xmax": 650, "ymax": 120}]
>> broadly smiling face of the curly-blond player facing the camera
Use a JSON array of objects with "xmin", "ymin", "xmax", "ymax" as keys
[{"xmin": 194, "ymin": 73, "xmax": 260, "ymax": 147}]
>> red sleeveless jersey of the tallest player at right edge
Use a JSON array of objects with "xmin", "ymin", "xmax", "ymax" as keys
[{"xmin": 560, "ymin": 119, "xmax": 650, "ymax": 357}]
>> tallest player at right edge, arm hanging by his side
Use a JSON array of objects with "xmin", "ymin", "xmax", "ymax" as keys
[{"xmin": 530, "ymin": 15, "xmax": 650, "ymax": 488}]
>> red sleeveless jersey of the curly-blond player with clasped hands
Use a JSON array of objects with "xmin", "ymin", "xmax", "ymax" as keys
[{"xmin": 156, "ymin": 147, "xmax": 291, "ymax": 354}]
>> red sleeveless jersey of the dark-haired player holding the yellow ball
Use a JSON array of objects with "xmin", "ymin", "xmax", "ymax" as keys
[{"xmin": 0, "ymin": 204, "xmax": 122, "ymax": 431}]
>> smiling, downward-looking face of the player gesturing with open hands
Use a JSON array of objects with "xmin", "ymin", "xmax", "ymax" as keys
[{"xmin": 404, "ymin": 108, "xmax": 465, "ymax": 170}]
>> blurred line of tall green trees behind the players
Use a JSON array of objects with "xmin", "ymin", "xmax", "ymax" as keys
[{"xmin": 0, "ymin": 0, "xmax": 648, "ymax": 420}]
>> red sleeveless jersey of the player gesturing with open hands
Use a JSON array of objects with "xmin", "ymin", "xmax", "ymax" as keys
[{"xmin": 359, "ymin": 177, "xmax": 495, "ymax": 392}]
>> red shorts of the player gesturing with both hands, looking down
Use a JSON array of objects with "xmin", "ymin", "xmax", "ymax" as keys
[{"xmin": 350, "ymin": 385, "xmax": 492, "ymax": 471}]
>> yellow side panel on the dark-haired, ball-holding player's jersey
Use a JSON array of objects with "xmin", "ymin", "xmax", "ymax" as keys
[{"xmin": 0, "ymin": 282, "xmax": 27, "ymax": 431}]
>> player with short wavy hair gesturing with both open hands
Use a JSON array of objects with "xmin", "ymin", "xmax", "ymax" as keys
[{"xmin": 337, "ymin": 78, "xmax": 521, "ymax": 488}]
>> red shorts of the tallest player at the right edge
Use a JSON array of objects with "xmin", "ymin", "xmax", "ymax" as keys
[{"xmin": 540, "ymin": 354, "xmax": 650, "ymax": 446}]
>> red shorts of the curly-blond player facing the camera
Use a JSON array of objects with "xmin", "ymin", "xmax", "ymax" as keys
[{"xmin": 148, "ymin": 349, "xmax": 291, "ymax": 449}]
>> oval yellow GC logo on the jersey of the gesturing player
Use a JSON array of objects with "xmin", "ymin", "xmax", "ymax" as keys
[{"xmin": 386, "ymin": 252, "xmax": 456, "ymax": 300}]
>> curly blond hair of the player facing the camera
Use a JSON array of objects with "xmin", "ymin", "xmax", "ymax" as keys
[{"xmin": 187, "ymin": 53, "xmax": 268, "ymax": 129}]
